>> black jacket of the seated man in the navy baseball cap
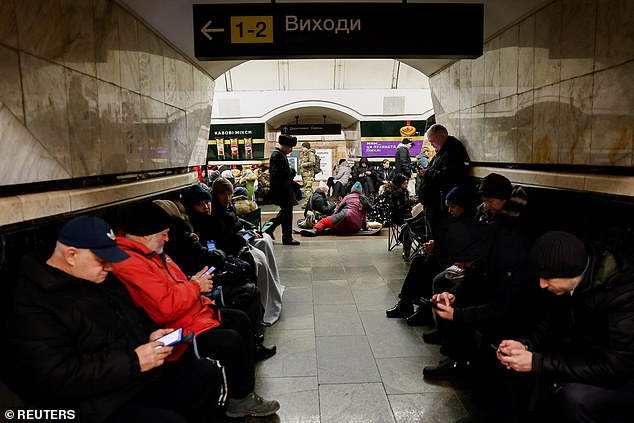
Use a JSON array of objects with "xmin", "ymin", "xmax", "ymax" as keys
[{"xmin": 7, "ymin": 257, "xmax": 161, "ymax": 422}]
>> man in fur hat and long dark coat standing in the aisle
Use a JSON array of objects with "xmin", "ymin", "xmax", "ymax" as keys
[{"xmin": 265, "ymin": 134, "xmax": 299, "ymax": 245}]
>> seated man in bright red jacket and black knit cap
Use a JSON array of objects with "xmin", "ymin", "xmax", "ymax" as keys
[{"xmin": 113, "ymin": 202, "xmax": 280, "ymax": 417}]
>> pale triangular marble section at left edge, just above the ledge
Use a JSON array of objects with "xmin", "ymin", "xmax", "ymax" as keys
[{"xmin": 0, "ymin": 102, "xmax": 71, "ymax": 185}]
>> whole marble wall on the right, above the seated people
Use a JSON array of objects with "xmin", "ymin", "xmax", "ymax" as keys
[{"xmin": 430, "ymin": 0, "xmax": 634, "ymax": 166}]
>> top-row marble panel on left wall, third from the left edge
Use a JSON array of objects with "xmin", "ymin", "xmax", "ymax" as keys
[{"xmin": 60, "ymin": 0, "xmax": 97, "ymax": 76}]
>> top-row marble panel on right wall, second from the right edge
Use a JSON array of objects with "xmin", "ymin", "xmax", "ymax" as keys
[{"xmin": 561, "ymin": 0, "xmax": 597, "ymax": 80}]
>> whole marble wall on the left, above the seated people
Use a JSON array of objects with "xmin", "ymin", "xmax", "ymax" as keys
[{"xmin": 0, "ymin": 0, "xmax": 214, "ymax": 186}]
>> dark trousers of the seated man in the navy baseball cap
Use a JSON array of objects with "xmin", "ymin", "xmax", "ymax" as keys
[{"xmin": 104, "ymin": 360, "xmax": 223, "ymax": 423}]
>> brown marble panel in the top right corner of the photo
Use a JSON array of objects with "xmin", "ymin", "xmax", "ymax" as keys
[{"xmin": 594, "ymin": 0, "xmax": 634, "ymax": 71}]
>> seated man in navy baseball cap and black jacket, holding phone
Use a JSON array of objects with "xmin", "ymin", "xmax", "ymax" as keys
[{"xmin": 6, "ymin": 216, "xmax": 225, "ymax": 423}]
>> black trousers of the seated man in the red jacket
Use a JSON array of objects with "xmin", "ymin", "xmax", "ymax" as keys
[{"xmin": 184, "ymin": 308, "xmax": 255, "ymax": 398}]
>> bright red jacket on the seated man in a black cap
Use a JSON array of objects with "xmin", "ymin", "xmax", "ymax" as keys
[{"xmin": 112, "ymin": 233, "xmax": 220, "ymax": 360}]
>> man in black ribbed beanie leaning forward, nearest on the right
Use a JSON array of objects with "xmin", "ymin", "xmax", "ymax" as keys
[{"xmin": 497, "ymin": 231, "xmax": 634, "ymax": 422}]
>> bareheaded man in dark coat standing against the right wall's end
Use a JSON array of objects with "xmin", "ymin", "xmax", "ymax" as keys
[{"xmin": 419, "ymin": 124, "xmax": 469, "ymax": 231}]
